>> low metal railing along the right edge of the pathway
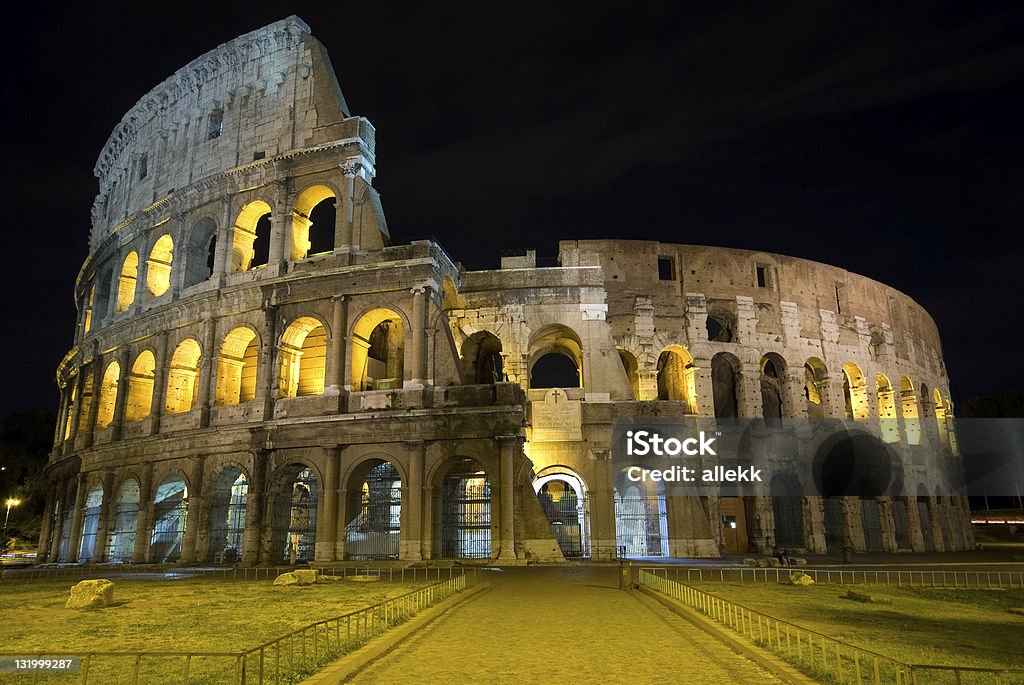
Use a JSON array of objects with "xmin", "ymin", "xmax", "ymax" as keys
[{"xmin": 638, "ymin": 568, "xmax": 1024, "ymax": 685}]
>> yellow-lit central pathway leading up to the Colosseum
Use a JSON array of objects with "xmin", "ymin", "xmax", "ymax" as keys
[{"xmin": 350, "ymin": 567, "xmax": 779, "ymax": 685}]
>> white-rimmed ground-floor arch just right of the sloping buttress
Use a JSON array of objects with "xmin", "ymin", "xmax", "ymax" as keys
[{"xmin": 534, "ymin": 472, "xmax": 590, "ymax": 559}]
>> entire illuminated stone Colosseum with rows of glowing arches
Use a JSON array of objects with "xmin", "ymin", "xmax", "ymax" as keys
[{"xmin": 40, "ymin": 16, "xmax": 973, "ymax": 564}]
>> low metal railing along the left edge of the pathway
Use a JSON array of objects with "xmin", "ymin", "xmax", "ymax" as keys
[{"xmin": 0, "ymin": 569, "xmax": 479, "ymax": 685}]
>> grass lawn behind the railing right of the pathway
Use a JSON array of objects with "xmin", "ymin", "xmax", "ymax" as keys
[{"xmin": 695, "ymin": 583, "xmax": 1024, "ymax": 669}]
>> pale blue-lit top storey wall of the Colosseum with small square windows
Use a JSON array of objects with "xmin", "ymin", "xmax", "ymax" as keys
[{"xmin": 90, "ymin": 16, "xmax": 360, "ymax": 250}]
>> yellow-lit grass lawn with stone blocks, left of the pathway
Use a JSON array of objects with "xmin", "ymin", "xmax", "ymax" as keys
[{"xmin": 0, "ymin": 579, "xmax": 427, "ymax": 683}]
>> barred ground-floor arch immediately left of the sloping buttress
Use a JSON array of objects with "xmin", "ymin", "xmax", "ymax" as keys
[{"xmin": 440, "ymin": 457, "xmax": 489, "ymax": 559}]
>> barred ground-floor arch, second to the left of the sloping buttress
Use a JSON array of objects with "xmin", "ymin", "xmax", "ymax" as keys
[{"xmin": 345, "ymin": 459, "xmax": 401, "ymax": 560}]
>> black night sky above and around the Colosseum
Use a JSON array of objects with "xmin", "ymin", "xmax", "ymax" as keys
[{"xmin": 0, "ymin": 2, "xmax": 1024, "ymax": 417}]
